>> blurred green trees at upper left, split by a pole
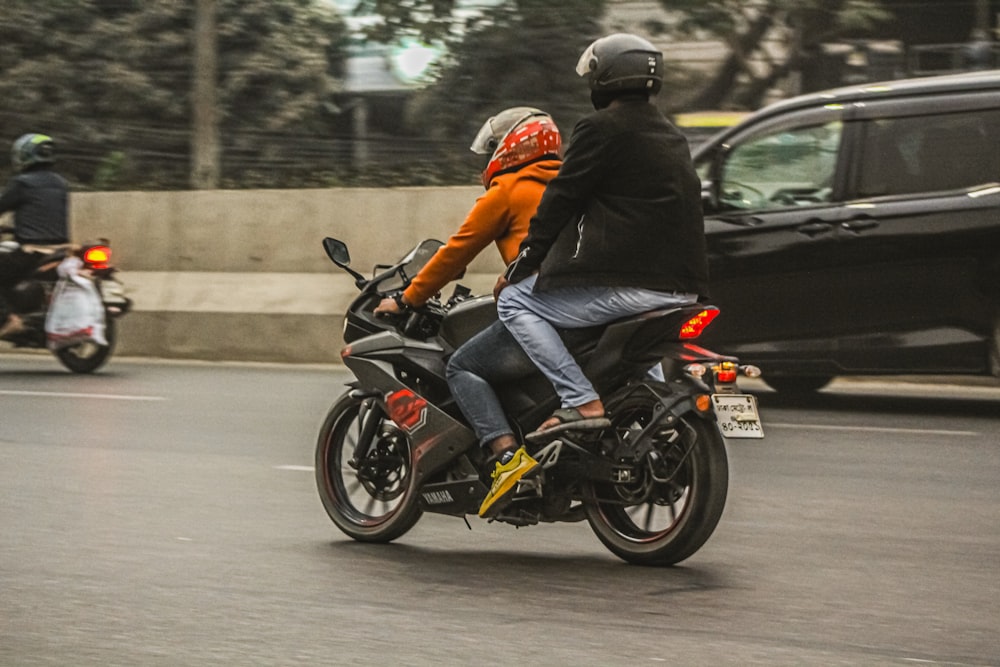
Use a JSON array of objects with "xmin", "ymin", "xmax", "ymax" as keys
[{"xmin": 0, "ymin": 0, "xmax": 347, "ymax": 187}]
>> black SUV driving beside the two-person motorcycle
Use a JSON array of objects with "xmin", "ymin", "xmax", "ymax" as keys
[{"xmin": 693, "ymin": 70, "xmax": 1000, "ymax": 391}]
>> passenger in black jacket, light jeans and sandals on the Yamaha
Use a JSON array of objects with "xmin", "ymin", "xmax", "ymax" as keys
[{"xmin": 495, "ymin": 34, "xmax": 708, "ymax": 477}]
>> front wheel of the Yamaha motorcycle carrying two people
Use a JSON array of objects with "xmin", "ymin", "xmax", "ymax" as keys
[{"xmin": 316, "ymin": 394, "xmax": 421, "ymax": 542}]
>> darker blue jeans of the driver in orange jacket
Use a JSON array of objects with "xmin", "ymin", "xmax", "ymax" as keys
[{"xmin": 446, "ymin": 322, "xmax": 535, "ymax": 447}]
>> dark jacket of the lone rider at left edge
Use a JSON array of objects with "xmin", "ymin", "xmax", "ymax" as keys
[{"xmin": 0, "ymin": 168, "xmax": 69, "ymax": 243}]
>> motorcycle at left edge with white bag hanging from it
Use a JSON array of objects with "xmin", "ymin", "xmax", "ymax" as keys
[{"xmin": 0, "ymin": 228, "xmax": 132, "ymax": 373}]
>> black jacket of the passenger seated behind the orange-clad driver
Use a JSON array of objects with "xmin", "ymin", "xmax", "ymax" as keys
[{"xmin": 507, "ymin": 98, "xmax": 708, "ymax": 296}]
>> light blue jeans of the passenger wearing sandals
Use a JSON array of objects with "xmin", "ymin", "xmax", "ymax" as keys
[{"xmin": 497, "ymin": 274, "xmax": 698, "ymax": 408}]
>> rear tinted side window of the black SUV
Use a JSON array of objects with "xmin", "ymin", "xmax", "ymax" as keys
[{"xmin": 857, "ymin": 109, "xmax": 1000, "ymax": 197}]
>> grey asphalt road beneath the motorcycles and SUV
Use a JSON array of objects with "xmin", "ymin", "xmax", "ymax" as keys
[{"xmin": 0, "ymin": 355, "xmax": 1000, "ymax": 667}]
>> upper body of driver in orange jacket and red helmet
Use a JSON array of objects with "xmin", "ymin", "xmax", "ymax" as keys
[{"xmin": 375, "ymin": 107, "xmax": 562, "ymax": 315}]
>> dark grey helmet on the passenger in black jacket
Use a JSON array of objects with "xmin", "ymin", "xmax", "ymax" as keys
[{"xmin": 576, "ymin": 33, "xmax": 663, "ymax": 109}]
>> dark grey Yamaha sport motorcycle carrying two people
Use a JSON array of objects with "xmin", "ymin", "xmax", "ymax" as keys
[{"xmin": 315, "ymin": 237, "xmax": 763, "ymax": 565}]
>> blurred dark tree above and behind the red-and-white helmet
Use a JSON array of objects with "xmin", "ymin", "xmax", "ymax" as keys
[{"xmin": 356, "ymin": 0, "xmax": 607, "ymax": 167}]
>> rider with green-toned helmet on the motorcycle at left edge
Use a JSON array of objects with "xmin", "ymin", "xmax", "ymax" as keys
[{"xmin": 0, "ymin": 134, "xmax": 69, "ymax": 337}]
